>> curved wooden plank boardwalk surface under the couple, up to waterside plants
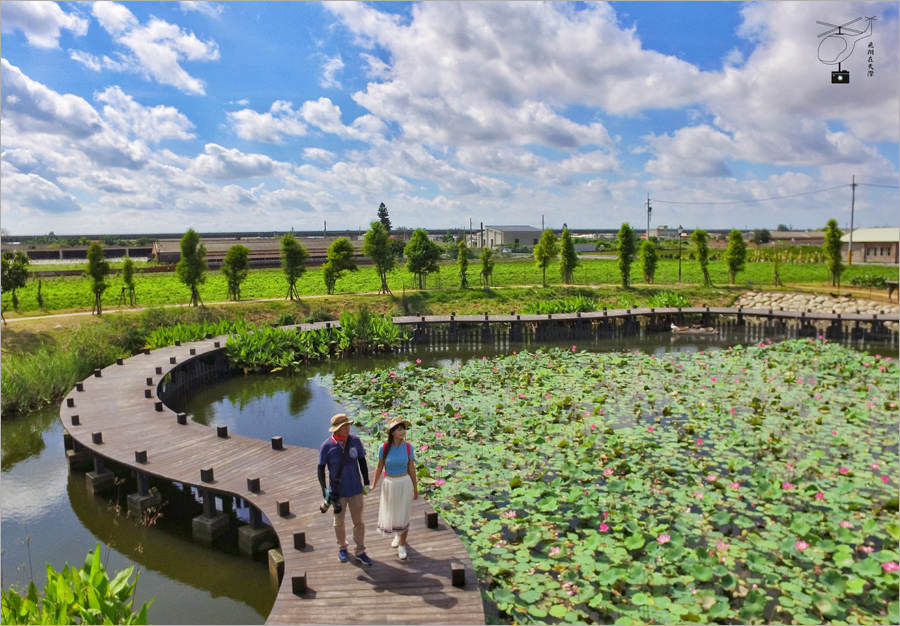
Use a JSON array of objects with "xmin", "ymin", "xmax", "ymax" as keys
[{"xmin": 60, "ymin": 340, "xmax": 484, "ymax": 624}]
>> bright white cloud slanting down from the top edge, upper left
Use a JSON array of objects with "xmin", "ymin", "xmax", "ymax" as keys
[{"xmin": 88, "ymin": 2, "xmax": 219, "ymax": 94}]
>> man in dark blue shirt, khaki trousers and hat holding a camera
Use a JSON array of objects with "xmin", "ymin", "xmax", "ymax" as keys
[{"xmin": 319, "ymin": 413, "xmax": 372, "ymax": 565}]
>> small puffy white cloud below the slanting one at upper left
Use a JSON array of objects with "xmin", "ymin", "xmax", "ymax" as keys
[{"xmin": 95, "ymin": 86, "xmax": 194, "ymax": 143}]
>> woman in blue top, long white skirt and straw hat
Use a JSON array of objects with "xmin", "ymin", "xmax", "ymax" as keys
[{"xmin": 372, "ymin": 417, "xmax": 419, "ymax": 559}]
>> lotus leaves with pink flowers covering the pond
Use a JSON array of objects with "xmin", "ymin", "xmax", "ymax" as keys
[{"xmin": 333, "ymin": 339, "xmax": 900, "ymax": 624}]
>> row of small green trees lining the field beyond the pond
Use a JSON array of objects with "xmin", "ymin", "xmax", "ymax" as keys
[{"xmin": 2, "ymin": 214, "xmax": 856, "ymax": 315}]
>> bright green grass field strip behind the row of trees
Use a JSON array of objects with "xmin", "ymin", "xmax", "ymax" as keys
[{"xmin": 3, "ymin": 259, "xmax": 898, "ymax": 314}]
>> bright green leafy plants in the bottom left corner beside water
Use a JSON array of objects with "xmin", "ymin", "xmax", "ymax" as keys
[{"xmin": 2, "ymin": 543, "xmax": 153, "ymax": 624}]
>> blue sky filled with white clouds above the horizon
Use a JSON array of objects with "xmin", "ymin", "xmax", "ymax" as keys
[{"xmin": 0, "ymin": 1, "xmax": 900, "ymax": 235}]
